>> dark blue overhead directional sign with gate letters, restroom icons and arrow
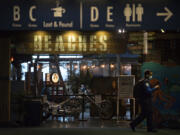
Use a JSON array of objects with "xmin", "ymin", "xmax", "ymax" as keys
[{"xmin": 0, "ymin": 0, "xmax": 180, "ymax": 30}]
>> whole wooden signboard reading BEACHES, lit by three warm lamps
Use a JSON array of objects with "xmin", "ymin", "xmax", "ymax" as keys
[{"xmin": 15, "ymin": 31, "xmax": 125, "ymax": 54}]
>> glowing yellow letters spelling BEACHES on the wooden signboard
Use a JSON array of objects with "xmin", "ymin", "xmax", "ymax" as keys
[{"xmin": 33, "ymin": 35, "xmax": 108, "ymax": 52}]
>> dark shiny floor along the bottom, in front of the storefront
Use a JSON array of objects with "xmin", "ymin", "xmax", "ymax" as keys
[{"xmin": 0, "ymin": 117, "xmax": 180, "ymax": 135}]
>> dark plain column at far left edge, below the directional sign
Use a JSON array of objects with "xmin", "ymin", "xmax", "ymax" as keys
[{"xmin": 0, "ymin": 38, "xmax": 10, "ymax": 122}]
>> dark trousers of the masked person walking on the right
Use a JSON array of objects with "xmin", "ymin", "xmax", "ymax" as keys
[{"xmin": 131, "ymin": 98, "xmax": 153, "ymax": 130}]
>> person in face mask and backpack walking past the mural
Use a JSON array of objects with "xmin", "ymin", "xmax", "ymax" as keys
[{"xmin": 130, "ymin": 70, "xmax": 159, "ymax": 132}]
